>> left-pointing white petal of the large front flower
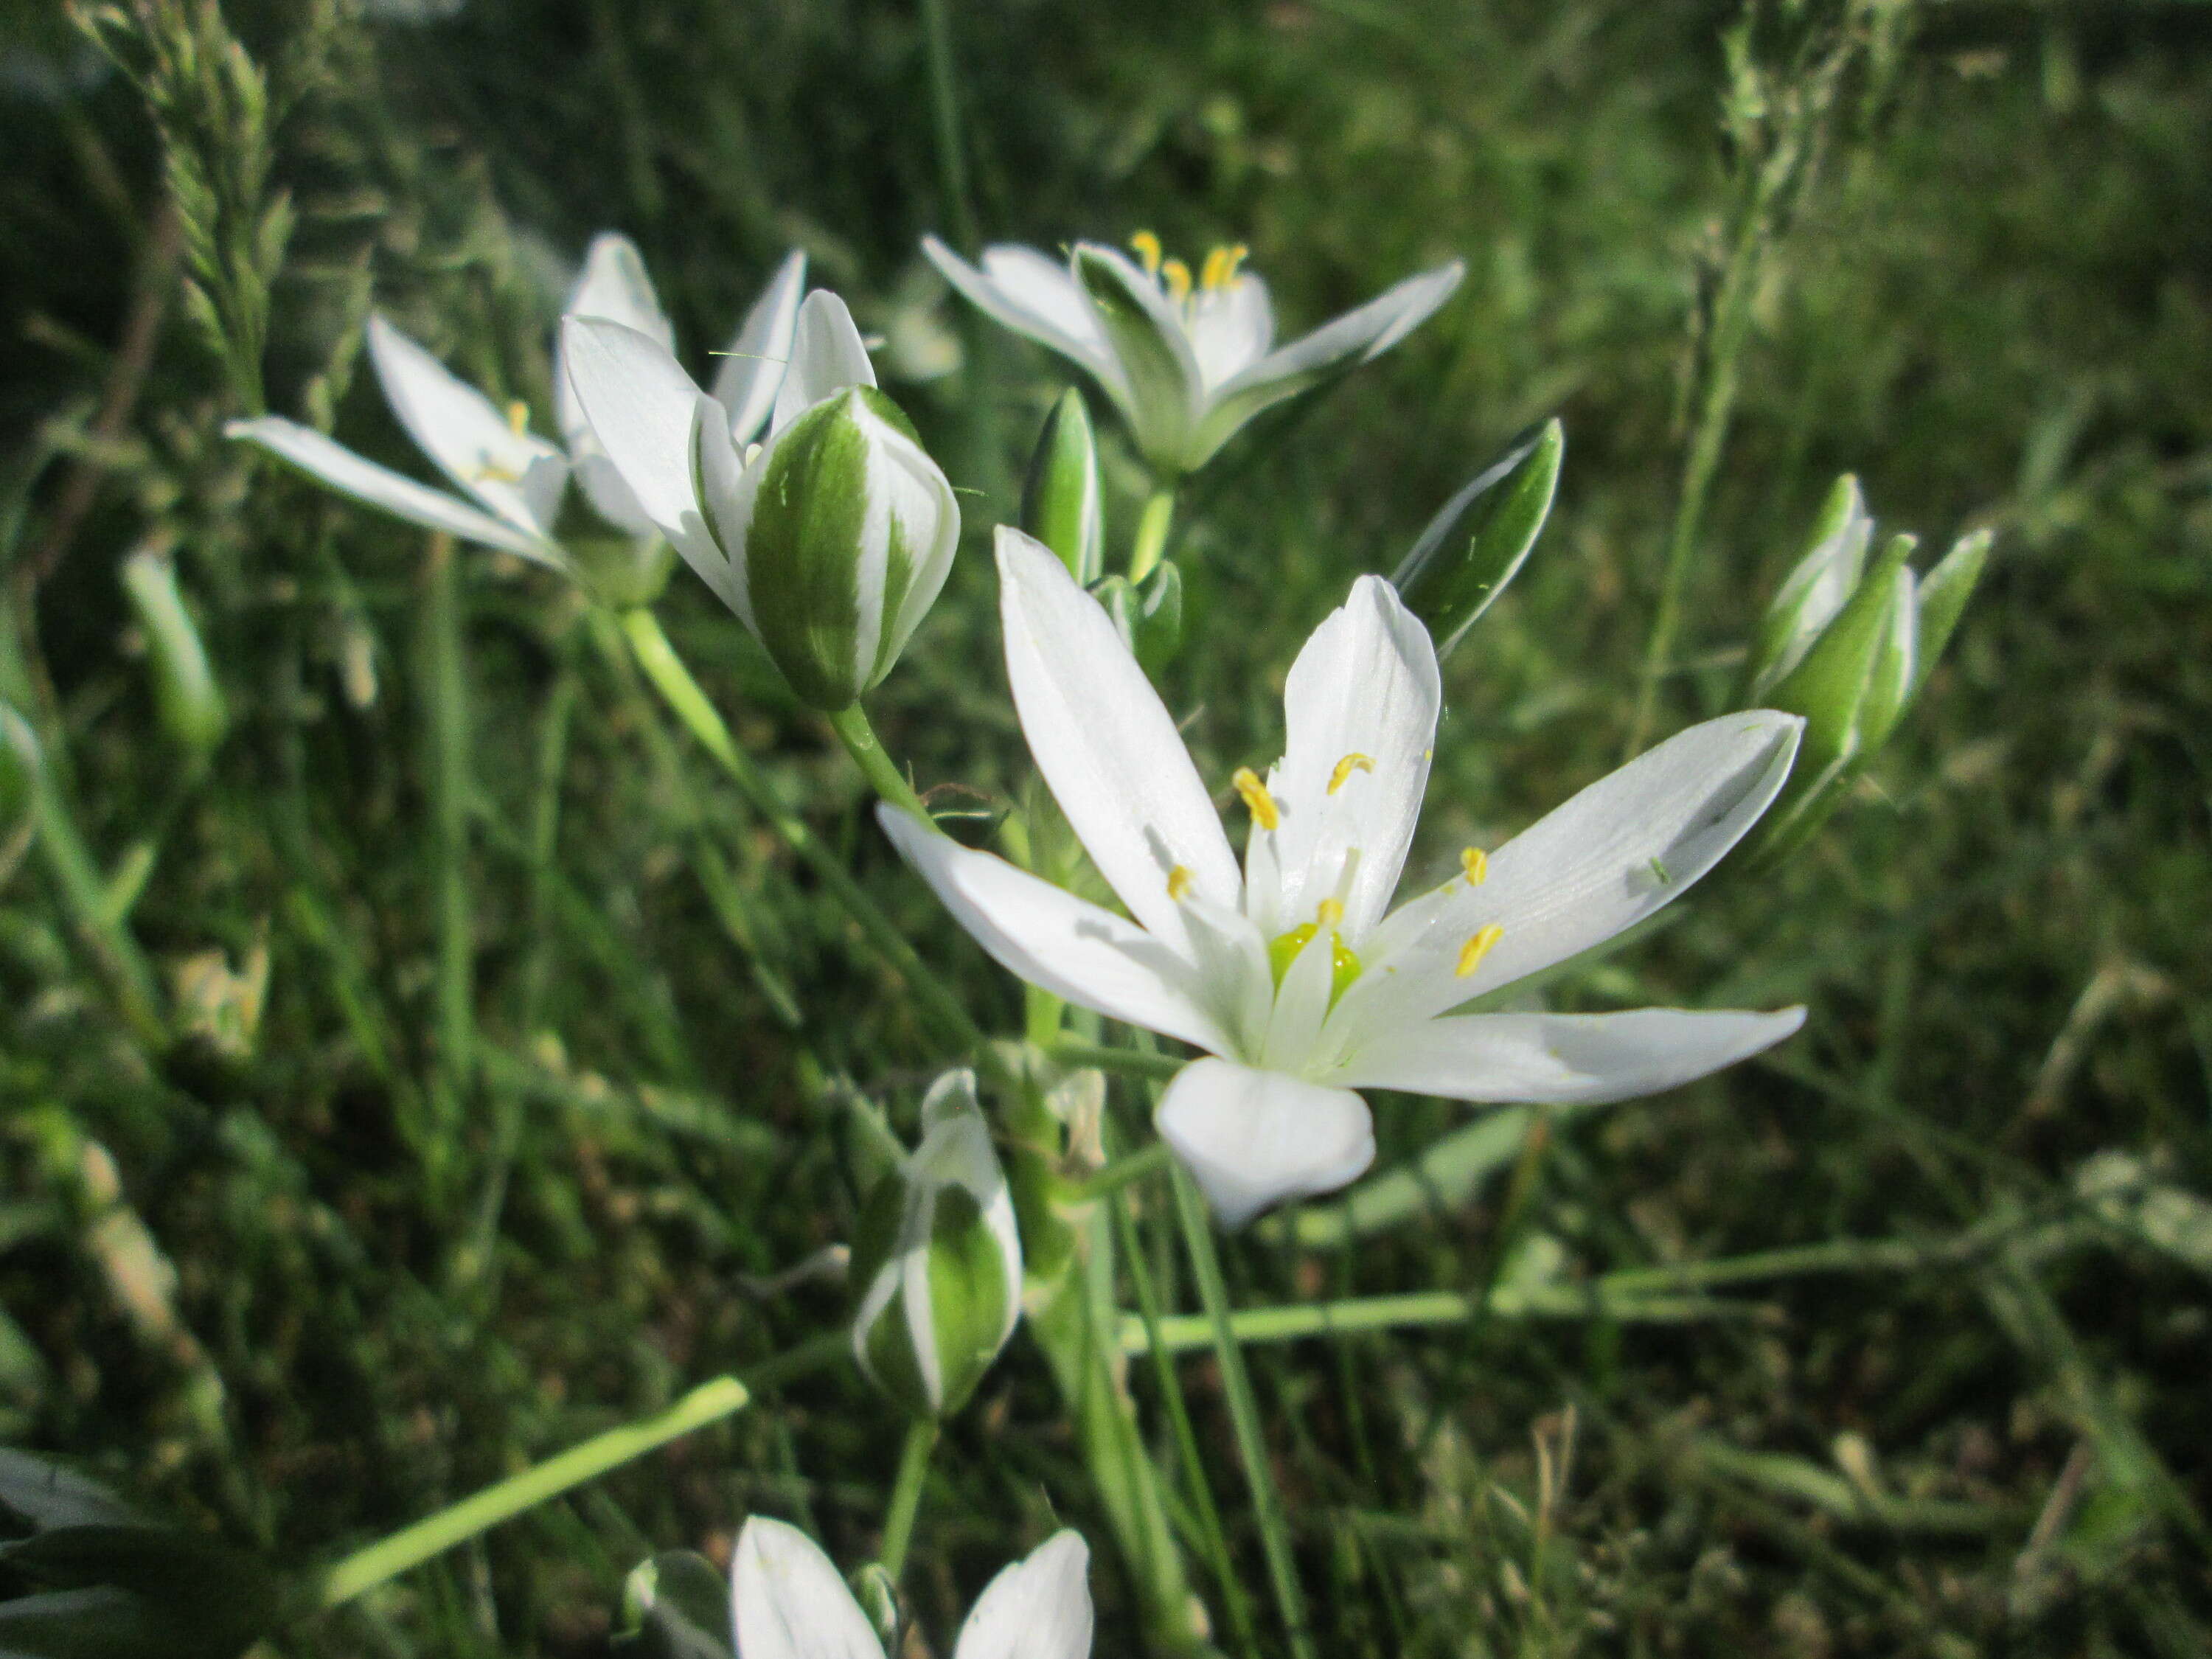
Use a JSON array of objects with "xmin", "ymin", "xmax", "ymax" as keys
[{"xmin": 876, "ymin": 805, "xmax": 1230, "ymax": 1053}]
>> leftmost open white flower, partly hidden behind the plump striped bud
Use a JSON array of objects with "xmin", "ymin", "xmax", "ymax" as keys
[{"xmin": 223, "ymin": 232, "xmax": 807, "ymax": 568}]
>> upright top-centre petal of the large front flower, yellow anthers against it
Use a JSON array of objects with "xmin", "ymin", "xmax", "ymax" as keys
[{"xmin": 1245, "ymin": 575, "xmax": 1442, "ymax": 949}]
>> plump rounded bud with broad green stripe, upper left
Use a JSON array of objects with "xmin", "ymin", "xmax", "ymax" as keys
[{"xmin": 734, "ymin": 385, "xmax": 960, "ymax": 712}]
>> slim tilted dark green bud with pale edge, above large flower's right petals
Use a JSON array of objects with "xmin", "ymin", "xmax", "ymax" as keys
[{"xmin": 1391, "ymin": 420, "xmax": 1566, "ymax": 657}]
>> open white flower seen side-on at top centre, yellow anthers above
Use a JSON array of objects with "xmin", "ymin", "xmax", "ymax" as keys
[{"xmin": 922, "ymin": 232, "xmax": 1467, "ymax": 476}]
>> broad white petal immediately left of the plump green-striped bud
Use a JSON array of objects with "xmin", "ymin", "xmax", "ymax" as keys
[{"xmin": 560, "ymin": 316, "xmax": 730, "ymax": 595}]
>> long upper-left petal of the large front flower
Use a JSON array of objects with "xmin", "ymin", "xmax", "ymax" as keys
[{"xmin": 998, "ymin": 524, "xmax": 1241, "ymax": 960}]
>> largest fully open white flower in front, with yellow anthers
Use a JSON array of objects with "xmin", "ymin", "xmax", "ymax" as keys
[{"xmin": 880, "ymin": 529, "xmax": 1805, "ymax": 1225}]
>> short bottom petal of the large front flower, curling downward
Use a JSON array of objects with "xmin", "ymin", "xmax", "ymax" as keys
[{"xmin": 1152, "ymin": 1060, "xmax": 1376, "ymax": 1228}]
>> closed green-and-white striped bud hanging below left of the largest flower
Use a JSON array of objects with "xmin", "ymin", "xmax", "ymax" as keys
[{"xmin": 852, "ymin": 1071, "xmax": 1022, "ymax": 1418}]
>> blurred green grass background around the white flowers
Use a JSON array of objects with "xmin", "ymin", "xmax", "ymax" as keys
[{"xmin": 0, "ymin": 0, "xmax": 2212, "ymax": 1655}]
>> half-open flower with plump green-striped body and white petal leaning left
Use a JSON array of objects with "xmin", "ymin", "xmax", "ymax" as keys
[{"xmin": 562, "ymin": 290, "xmax": 960, "ymax": 712}]
